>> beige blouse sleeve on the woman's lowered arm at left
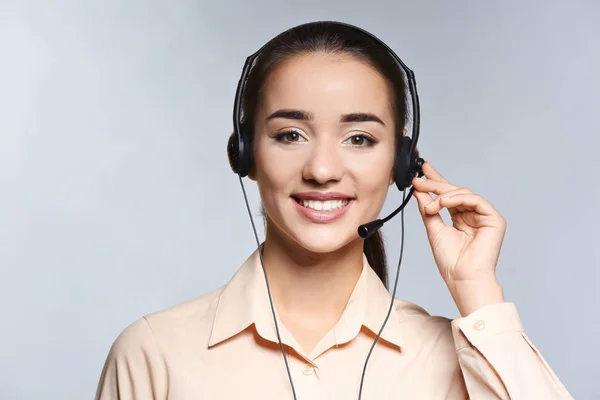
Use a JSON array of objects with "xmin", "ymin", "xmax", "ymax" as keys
[{"xmin": 95, "ymin": 318, "xmax": 168, "ymax": 400}]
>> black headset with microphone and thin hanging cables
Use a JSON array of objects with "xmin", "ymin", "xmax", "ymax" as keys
[{"xmin": 227, "ymin": 21, "xmax": 425, "ymax": 400}]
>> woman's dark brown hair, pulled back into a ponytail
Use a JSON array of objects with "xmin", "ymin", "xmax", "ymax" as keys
[{"xmin": 241, "ymin": 22, "xmax": 408, "ymax": 287}]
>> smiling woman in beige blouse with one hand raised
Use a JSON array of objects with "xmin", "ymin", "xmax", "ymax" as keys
[{"xmin": 96, "ymin": 22, "xmax": 571, "ymax": 400}]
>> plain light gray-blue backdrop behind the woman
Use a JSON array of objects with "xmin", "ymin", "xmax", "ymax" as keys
[{"xmin": 0, "ymin": 0, "xmax": 600, "ymax": 399}]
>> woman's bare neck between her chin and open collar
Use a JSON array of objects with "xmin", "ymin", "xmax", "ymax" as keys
[{"xmin": 263, "ymin": 222, "xmax": 363, "ymax": 325}]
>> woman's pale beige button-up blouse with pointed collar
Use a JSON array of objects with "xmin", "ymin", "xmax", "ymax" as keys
[{"xmin": 96, "ymin": 248, "xmax": 572, "ymax": 400}]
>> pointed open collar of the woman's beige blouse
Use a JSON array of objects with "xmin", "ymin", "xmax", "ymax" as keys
[{"xmin": 208, "ymin": 245, "xmax": 402, "ymax": 348}]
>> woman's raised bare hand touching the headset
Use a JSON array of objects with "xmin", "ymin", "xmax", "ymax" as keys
[{"xmin": 412, "ymin": 162, "xmax": 506, "ymax": 316}]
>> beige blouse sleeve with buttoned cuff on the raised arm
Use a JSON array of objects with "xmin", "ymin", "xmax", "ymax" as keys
[{"xmin": 451, "ymin": 303, "xmax": 573, "ymax": 400}]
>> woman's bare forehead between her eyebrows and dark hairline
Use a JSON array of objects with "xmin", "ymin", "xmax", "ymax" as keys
[{"xmin": 261, "ymin": 53, "xmax": 391, "ymax": 119}]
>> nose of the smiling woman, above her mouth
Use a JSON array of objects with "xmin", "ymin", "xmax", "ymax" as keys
[{"xmin": 302, "ymin": 140, "xmax": 345, "ymax": 185}]
